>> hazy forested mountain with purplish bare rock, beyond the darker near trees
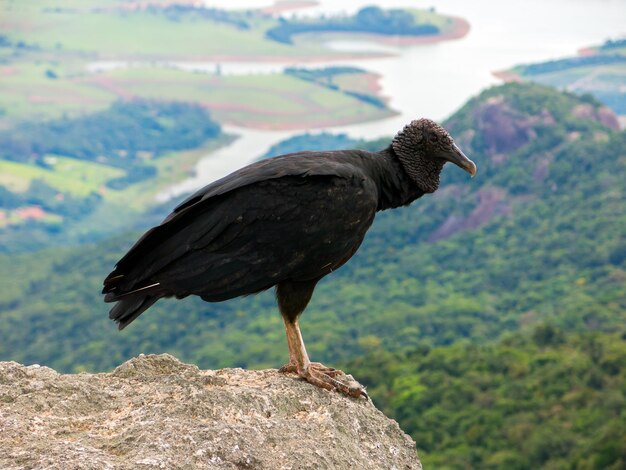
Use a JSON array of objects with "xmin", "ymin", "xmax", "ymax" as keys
[{"xmin": 0, "ymin": 84, "xmax": 626, "ymax": 371}]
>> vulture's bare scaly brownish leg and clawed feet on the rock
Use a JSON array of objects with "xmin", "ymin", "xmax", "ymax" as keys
[{"xmin": 280, "ymin": 317, "xmax": 367, "ymax": 398}]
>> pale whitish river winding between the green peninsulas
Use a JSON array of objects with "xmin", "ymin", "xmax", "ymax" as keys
[{"xmin": 158, "ymin": 0, "xmax": 626, "ymax": 200}]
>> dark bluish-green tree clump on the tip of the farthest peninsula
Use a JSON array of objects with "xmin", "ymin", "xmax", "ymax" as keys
[{"xmin": 265, "ymin": 6, "xmax": 439, "ymax": 44}]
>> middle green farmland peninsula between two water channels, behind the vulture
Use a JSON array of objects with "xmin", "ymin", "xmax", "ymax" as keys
[{"xmin": 0, "ymin": 63, "xmax": 392, "ymax": 128}]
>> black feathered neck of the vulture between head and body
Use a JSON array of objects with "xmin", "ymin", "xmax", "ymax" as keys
[{"xmin": 360, "ymin": 147, "xmax": 425, "ymax": 211}]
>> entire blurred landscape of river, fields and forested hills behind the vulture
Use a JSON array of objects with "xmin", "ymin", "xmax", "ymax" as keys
[{"xmin": 0, "ymin": 0, "xmax": 626, "ymax": 469}]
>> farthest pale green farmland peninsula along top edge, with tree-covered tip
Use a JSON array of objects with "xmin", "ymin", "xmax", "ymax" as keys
[{"xmin": 0, "ymin": 0, "xmax": 456, "ymax": 61}]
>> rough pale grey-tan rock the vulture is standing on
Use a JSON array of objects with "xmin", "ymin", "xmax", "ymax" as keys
[{"xmin": 0, "ymin": 355, "xmax": 421, "ymax": 470}]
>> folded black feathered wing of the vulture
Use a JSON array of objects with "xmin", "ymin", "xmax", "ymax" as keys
[{"xmin": 104, "ymin": 152, "xmax": 378, "ymax": 301}]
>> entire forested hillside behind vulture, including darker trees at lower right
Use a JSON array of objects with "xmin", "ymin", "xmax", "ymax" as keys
[{"xmin": 0, "ymin": 84, "xmax": 626, "ymax": 468}]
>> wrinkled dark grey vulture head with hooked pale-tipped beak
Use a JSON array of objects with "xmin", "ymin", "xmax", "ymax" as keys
[{"xmin": 391, "ymin": 119, "xmax": 476, "ymax": 193}]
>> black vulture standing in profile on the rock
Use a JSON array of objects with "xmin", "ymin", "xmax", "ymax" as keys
[{"xmin": 102, "ymin": 118, "xmax": 476, "ymax": 398}]
